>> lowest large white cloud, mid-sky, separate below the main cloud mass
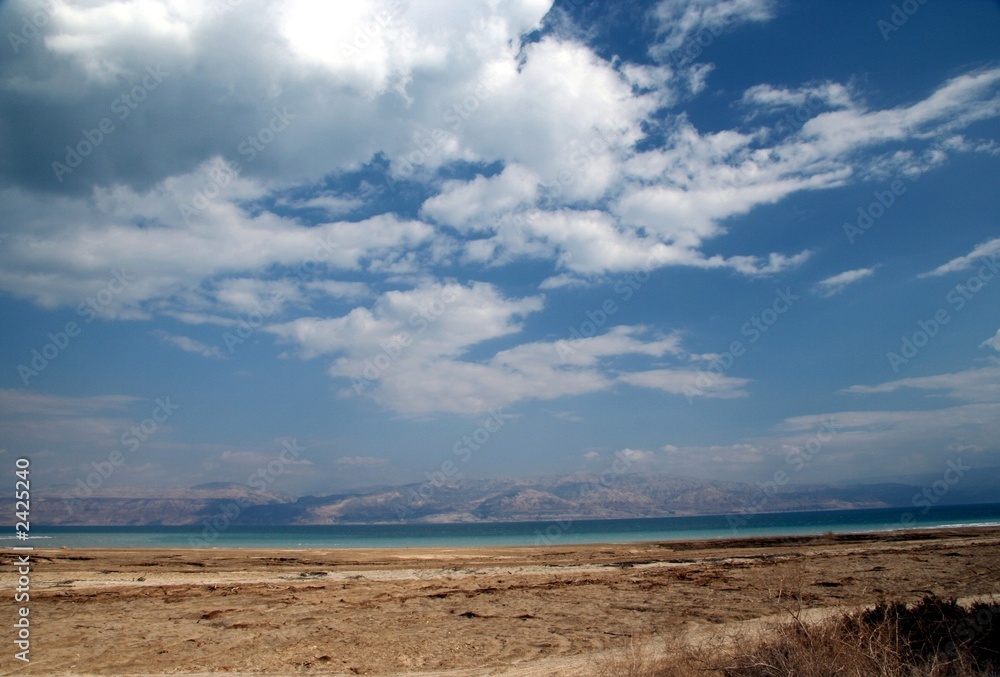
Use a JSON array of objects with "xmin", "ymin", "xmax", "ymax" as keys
[{"xmin": 274, "ymin": 283, "xmax": 745, "ymax": 416}]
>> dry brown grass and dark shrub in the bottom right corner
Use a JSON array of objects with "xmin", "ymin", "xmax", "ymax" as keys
[{"xmin": 598, "ymin": 597, "xmax": 1000, "ymax": 677}]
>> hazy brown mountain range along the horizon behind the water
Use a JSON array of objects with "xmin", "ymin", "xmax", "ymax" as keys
[{"xmin": 32, "ymin": 474, "xmax": 1000, "ymax": 526}]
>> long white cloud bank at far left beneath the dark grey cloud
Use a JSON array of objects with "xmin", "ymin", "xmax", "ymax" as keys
[{"xmin": 0, "ymin": 178, "xmax": 433, "ymax": 317}]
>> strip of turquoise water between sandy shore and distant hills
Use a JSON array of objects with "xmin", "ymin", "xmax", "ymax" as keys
[{"xmin": 7, "ymin": 504, "xmax": 1000, "ymax": 549}]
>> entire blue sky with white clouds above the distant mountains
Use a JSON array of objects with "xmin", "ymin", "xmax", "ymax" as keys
[{"xmin": 0, "ymin": 0, "xmax": 1000, "ymax": 495}]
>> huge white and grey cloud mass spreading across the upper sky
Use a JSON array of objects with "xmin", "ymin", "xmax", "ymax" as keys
[{"xmin": 0, "ymin": 0, "xmax": 1000, "ymax": 308}]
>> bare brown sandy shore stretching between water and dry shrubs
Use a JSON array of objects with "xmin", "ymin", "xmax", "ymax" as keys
[{"xmin": 0, "ymin": 528, "xmax": 1000, "ymax": 676}]
